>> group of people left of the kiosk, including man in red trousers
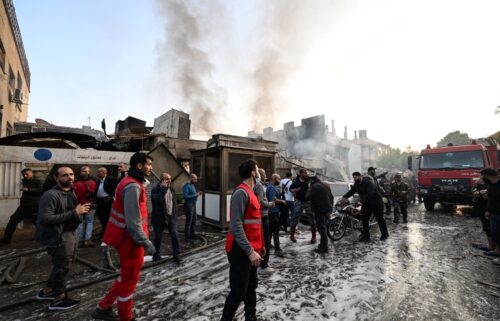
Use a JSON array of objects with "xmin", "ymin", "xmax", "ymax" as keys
[{"xmin": 0, "ymin": 153, "xmax": 201, "ymax": 320}]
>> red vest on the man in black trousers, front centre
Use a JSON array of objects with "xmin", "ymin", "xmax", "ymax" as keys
[{"xmin": 226, "ymin": 183, "xmax": 264, "ymax": 253}]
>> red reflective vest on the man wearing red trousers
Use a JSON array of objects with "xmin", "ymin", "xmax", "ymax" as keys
[{"xmin": 102, "ymin": 176, "xmax": 149, "ymax": 247}]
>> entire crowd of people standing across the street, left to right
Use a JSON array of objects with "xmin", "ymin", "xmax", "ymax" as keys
[{"xmin": 1, "ymin": 153, "xmax": 500, "ymax": 321}]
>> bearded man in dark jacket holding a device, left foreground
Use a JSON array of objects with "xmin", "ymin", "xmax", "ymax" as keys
[{"xmin": 36, "ymin": 166, "xmax": 90, "ymax": 311}]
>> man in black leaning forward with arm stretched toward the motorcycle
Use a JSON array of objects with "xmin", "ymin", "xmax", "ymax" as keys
[{"xmin": 342, "ymin": 172, "xmax": 389, "ymax": 242}]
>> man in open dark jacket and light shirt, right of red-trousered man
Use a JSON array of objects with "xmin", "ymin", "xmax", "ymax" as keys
[{"xmin": 151, "ymin": 173, "xmax": 181, "ymax": 263}]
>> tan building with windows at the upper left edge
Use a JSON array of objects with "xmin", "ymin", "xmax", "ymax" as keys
[{"xmin": 0, "ymin": 0, "xmax": 30, "ymax": 137}]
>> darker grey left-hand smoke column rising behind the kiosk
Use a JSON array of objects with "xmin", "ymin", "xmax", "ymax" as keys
[{"xmin": 158, "ymin": 0, "xmax": 226, "ymax": 134}]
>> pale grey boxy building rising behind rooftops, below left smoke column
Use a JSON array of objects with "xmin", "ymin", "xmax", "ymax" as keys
[{"xmin": 153, "ymin": 109, "xmax": 191, "ymax": 139}]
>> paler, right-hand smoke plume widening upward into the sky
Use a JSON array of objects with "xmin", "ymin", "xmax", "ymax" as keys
[{"xmin": 252, "ymin": 0, "xmax": 329, "ymax": 131}]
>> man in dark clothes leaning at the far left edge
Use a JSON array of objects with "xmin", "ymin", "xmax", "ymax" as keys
[{"xmin": 1, "ymin": 168, "xmax": 42, "ymax": 244}]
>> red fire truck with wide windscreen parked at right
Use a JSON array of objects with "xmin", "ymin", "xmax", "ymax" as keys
[{"xmin": 418, "ymin": 138, "xmax": 500, "ymax": 211}]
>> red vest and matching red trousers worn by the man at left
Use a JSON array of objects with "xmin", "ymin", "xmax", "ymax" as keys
[{"xmin": 99, "ymin": 176, "xmax": 149, "ymax": 321}]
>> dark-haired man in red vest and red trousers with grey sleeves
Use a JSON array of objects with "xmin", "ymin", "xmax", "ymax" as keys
[{"xmin": 92, "ymin": 153, "xmax": 155, "ymax": 321}]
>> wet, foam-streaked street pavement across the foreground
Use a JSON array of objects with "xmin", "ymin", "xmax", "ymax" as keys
[{"xmin": 0, "ymin": 205, "xmax": 500, "ymax": 321}]
